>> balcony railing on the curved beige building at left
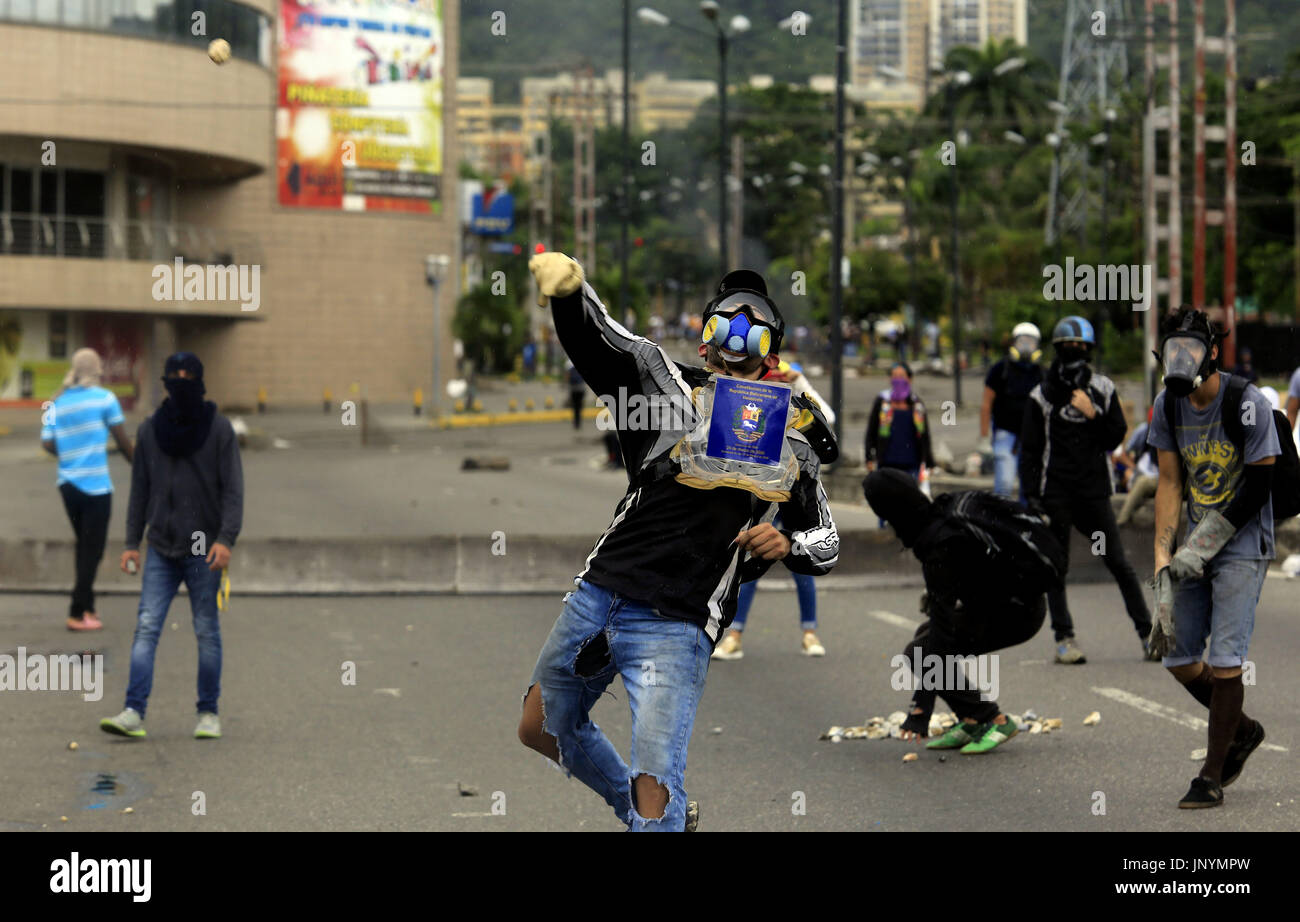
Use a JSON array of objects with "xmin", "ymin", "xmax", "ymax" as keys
[{"xmin": 0, "ymin": 212, "xmax": 264, "ymax": 265}]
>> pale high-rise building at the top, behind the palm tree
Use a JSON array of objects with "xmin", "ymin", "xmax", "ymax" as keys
[{"xmin": 849, "ymin": 0, "xmax": 1028, "ymax": 99}]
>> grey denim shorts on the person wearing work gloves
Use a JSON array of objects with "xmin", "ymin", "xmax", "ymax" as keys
[{"xmin": 1162, "ymin": 558, "xmax": 1269, "ymax": 668}]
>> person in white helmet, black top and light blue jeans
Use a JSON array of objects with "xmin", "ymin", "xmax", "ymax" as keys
[{"xmin": 979, "ymin": 323, "xmax": 1043, "ymax": 498}]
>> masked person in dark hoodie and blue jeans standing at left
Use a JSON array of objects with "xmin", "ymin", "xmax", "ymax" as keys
[{"xmin": 99, "ymin": 352, "xmax": 243, "ymax": 740}]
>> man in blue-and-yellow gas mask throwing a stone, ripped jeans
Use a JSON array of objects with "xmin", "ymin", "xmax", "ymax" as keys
[{"xmin": 519, "ymin": 252, "xmax": 840, "ymax": 831}]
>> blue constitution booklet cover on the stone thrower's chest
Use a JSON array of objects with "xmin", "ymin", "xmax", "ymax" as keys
[{"xmin": 705, "ymin": 375, "xmax": 790, "ymax": 467}]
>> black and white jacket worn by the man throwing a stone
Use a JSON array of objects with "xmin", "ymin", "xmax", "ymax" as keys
[{"xmin": 551, "ymin": 283, "xmax": 840, "ymax": 642}]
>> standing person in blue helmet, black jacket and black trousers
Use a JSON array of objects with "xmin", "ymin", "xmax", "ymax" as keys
[{"xmin": 1021, "ymin": 316, "xmax": 1151, "ymax": 663}]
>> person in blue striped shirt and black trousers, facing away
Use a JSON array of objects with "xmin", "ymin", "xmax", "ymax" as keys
[{"xmin": 40, "ymin": 349, "xmax": 133, "ymax": 631}]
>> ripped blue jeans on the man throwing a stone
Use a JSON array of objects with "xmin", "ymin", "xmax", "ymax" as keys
[{"xmin": 529, "ymin": 581, "xmax": 712, "ymax": 832}]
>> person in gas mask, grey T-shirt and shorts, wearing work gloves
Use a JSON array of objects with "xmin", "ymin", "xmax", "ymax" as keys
[{"xmin": 1147, "ymin": 306, "xmax": 1300, "ymax": 809}]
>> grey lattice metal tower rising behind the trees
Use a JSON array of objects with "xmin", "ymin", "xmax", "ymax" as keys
[{"xmin": 1045, "ymin": 0, "xmax": 1128, "ymax": 246}]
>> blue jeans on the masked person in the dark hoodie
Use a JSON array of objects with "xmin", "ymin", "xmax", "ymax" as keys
[{"xmin": 126, "ymin": 547, "xmax": 221, "ymax": 718}]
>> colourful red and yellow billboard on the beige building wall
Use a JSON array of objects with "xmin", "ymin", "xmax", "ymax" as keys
[{"xmin": 276, "ymin": 0, "xmax": 445, "ymax": 215}]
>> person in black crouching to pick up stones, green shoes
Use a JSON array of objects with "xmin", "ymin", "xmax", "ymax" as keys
[{"xmin": 862, "ymin": 469, "xmax": 1066, "ymax": 756}]
